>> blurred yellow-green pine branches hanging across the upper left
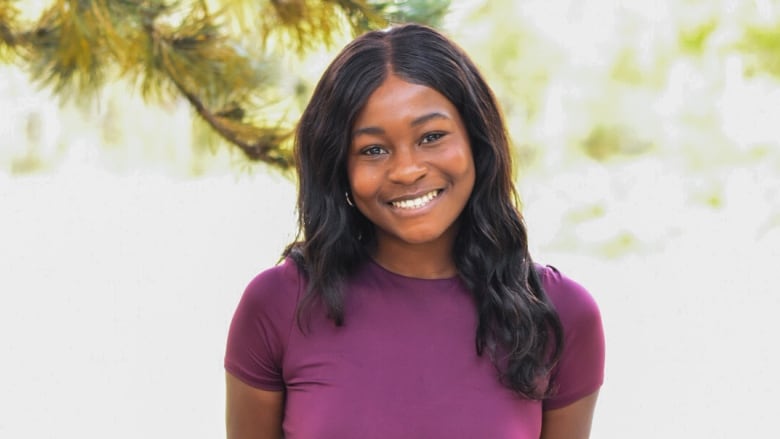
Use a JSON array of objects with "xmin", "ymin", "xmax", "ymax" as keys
[{"xmin": 0, "ymin": 0, "xmax": 449, "ymax": 169}]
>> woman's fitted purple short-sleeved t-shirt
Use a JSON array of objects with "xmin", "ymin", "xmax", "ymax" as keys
[{"xmin": 225, "ymin": 259, "xmax": 604, "ymax": 439}]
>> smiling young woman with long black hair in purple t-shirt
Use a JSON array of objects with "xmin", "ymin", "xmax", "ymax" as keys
[{"xmin": 225, "ymin": 25, "xmax": 604, "ymax": 439}]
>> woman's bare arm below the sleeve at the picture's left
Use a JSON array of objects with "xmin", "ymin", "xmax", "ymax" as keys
[{"xmin": 225, "ymin": 373, "xmax": 284, "ymax": 439}]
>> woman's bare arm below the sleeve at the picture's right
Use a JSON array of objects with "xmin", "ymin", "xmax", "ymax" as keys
[{"xmin": 540, "ymin": 390, "xmax": 599, "ymax": 439}]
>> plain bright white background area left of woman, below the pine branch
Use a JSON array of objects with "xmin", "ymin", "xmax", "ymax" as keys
[{"xmin": 0, "ymin": 169, "xmax": 294, "ymax": 438}]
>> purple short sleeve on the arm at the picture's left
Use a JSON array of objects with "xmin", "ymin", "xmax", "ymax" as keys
[{"xmin": 224, "ymin": 260, "xmax": 298, "ymax": 391}]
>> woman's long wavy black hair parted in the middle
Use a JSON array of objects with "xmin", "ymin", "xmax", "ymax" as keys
[{"xmin": 285, "ymin": 24, "xmax": 563, "ymax": 399}]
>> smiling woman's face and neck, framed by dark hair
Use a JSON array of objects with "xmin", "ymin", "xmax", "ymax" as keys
[{"xmin": 347, "ymin": 74, "xmax": 475, "ymax": 251}]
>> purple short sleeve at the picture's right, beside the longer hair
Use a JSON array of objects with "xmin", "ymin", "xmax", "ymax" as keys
[{"xmin": 537, "ymin": 266, "xmax": 605, "ymax": 410}]
